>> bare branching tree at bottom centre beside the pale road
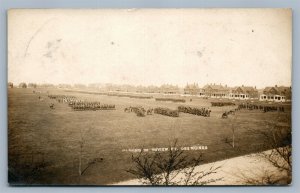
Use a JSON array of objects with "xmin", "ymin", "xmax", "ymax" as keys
[{"xmin": 126, "ymin": 140, "xmax": 222, "ymax": 186}]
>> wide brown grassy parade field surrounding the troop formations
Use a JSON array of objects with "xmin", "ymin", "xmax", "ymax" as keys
[{"xmin": 8, "ymin": 88, "xmax": 291, "ymax": 185}]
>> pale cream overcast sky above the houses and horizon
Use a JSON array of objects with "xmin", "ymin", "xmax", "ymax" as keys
[{"xmin": 8, "ymin": 9, "xmax": 292, "ymax": 88}]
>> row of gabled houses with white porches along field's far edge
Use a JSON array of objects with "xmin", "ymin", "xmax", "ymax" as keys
[{"xmin": 184, "ymin": 83, "xmax": 291, "ymax": 102}]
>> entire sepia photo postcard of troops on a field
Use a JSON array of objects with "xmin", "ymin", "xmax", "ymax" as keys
[{"xmin": 5, "ymin": 8, "xmax": 292, "ymax": 186}]
